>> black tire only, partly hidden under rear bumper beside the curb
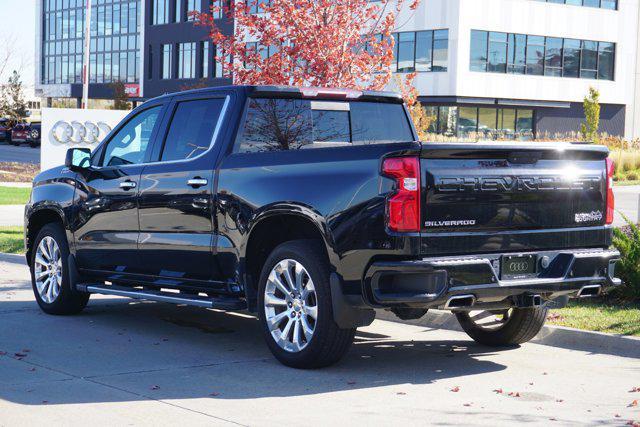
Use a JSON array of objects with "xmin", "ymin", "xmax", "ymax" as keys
[{"xmin": 456, "ymin": 307, "xmax": 547, "ymax": 347}]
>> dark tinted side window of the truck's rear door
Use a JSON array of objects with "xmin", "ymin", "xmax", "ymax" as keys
[{"xmin": 160, "ymin": 98, "xmax": 225, "ymax": 161}]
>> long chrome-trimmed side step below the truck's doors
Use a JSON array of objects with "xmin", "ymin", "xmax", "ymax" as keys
[{"xmin": 76, "ymin": 284, "xmax": 247, "ymax": 311}]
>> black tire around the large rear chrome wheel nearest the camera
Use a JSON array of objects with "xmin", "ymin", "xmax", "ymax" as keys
[{"xmin": 258, "ymin": 240, "xmax": 356, "ymax": 369}]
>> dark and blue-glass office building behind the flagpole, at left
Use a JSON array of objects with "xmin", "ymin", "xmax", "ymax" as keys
[{"xmin": 36, "ymin": 0, "xmax": 232, "ymax": 107}]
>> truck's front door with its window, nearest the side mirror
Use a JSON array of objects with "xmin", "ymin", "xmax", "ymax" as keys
[{"xmin": 74, "ymin": 104, "xmax": 164, "ymax": 274}]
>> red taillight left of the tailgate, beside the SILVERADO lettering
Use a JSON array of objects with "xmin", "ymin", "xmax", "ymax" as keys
[{"xmin": 382, "ymin": 157, "xmax": 420, "ymax": 233}]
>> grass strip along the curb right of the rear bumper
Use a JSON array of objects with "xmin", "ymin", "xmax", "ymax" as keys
[{"xmin": 547, "ymin": 300, "xmax": 640, "ymax": 336}]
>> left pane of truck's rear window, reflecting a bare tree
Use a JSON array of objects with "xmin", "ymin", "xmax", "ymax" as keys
[{"xmin": 240, "ymin": 98, "xmax": 313, "ymax": 153}]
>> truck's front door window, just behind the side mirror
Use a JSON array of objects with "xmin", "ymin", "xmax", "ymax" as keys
[{"xmin": 102, "ymin": 106, "xmax": 162, "ymax": 166}]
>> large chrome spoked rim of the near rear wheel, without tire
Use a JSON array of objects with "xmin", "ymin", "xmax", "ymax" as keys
[{"xmin": 264, "ymin": 259, "xmax": 318, "ymax": 353}]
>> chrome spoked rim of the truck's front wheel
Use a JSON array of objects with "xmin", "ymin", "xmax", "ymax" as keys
[{"xmin": 33, "ymin": 236, "xmax": 62, "ymax": 304}]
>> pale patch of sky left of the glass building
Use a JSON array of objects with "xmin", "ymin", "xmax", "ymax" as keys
[{"xmin": 0, "ymin": 0, "xmax": 38, "ymax": 97}]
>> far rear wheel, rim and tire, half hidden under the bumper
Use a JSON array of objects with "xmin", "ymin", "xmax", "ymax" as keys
[{"xmin": 456, "ymin": 307, "xmax": 547, "ymax": 347}]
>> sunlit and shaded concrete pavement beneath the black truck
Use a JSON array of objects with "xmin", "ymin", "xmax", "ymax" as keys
[{"xmin": 0, "ymin": 255, "xmax": 640, "ymax": 426}]
